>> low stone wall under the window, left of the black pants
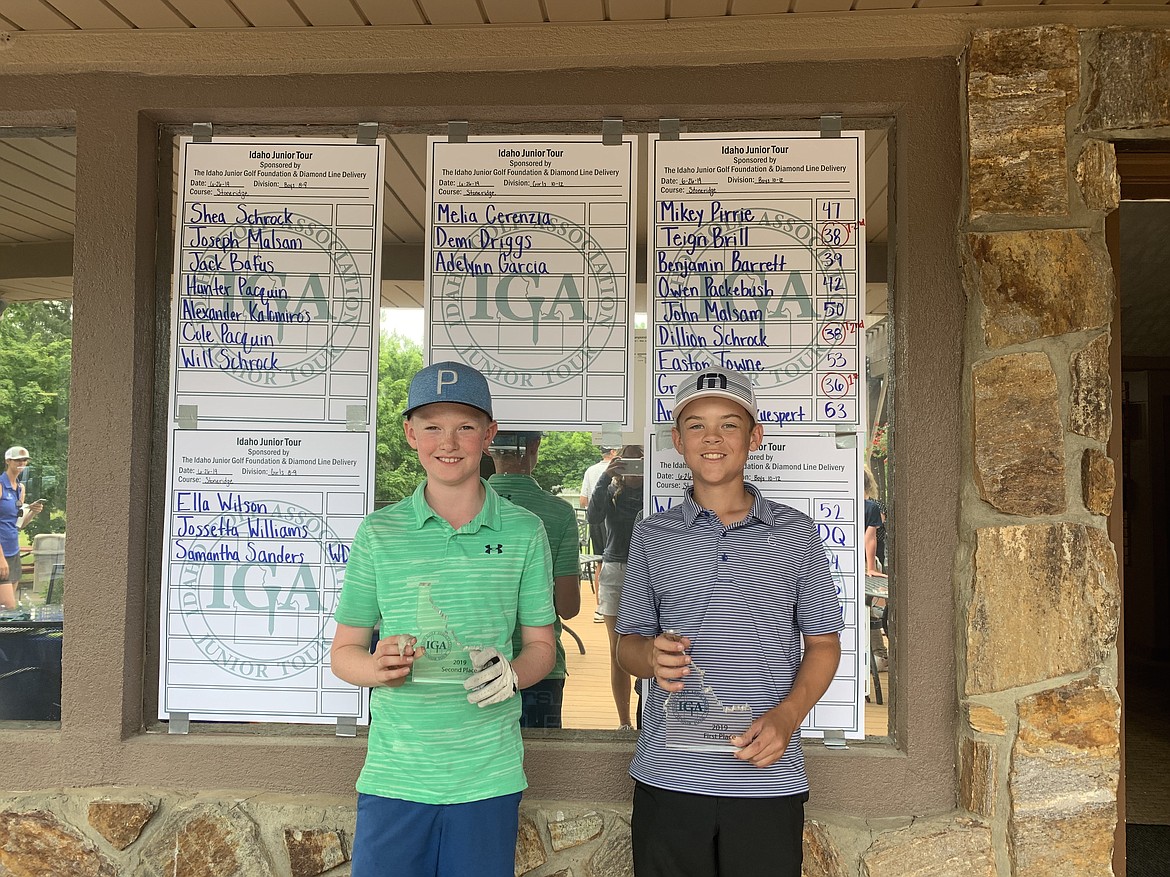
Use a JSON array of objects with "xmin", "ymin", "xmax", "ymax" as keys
[{"xmin": 0, "ymin": 788, "xmax": 641, "ymax": 877}]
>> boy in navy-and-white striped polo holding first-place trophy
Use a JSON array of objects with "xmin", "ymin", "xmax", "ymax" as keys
[{"xmin": 617, "ymin": 367, "xmax": 844, "ymax": 877}]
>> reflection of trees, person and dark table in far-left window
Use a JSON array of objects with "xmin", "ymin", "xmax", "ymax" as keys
[{"xmin": 0, "ymin": 301, "xmax": 73, "ymax": 721}]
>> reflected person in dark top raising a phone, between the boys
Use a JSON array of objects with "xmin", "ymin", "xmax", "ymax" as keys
[{"xmin": 589, "ymin": 444, "xmax": 642, "ymax": 731}]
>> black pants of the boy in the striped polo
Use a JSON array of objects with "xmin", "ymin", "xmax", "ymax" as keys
[{"xmin": 632, "ymin": 782, "xmax": 808, "ymax": 877}]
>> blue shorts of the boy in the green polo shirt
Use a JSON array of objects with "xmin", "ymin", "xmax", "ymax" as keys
[{"xmin": 351, "ymin": 792, "xmax": 521, "ymax": 877}]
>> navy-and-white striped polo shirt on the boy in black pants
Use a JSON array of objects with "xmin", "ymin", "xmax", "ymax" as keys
[{"xmin": 617, "ymin": 484, "xmax": 844, "ymax": 797}]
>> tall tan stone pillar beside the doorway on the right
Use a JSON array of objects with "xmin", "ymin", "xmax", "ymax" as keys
[{"xmin": 947, "ymin": 20, "xmax": 1137, "ymax": 877}]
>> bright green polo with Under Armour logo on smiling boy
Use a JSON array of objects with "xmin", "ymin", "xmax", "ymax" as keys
[{"xmin": 333, "ymin": 482, "xmax": 555, "ymax": 805}]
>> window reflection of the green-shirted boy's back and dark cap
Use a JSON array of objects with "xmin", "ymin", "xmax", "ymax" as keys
[{"xmin": 488, "ymin": 430, "xmax": 581, "ymax": 727}]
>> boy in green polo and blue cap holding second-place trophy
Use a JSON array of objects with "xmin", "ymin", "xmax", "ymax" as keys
[{"xmin": 330, "ymin": 362, "xmax": 555, "ymax": 877}]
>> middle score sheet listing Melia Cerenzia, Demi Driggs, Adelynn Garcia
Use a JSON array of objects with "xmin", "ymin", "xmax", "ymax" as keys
[{"xmin": 424, "ymin": 136, "xmax": 638, "ymax": 431}]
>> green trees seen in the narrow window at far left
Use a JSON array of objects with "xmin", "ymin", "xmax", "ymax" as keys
[{"xmin": 0, "ymin": 301, "xmax": 73, "ymax": 536}]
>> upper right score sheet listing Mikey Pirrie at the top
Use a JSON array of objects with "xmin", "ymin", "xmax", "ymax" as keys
[{"xmin": 647, "ymin": 132, "xmax": 865, "ymax": 431}]
